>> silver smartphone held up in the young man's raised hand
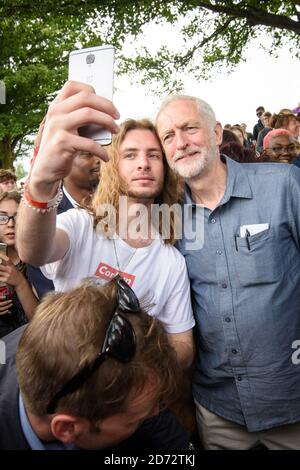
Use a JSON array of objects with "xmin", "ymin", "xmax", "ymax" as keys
[{"xmin": 69, "ymin": 45, "xmax": 115, "ymax": 145}]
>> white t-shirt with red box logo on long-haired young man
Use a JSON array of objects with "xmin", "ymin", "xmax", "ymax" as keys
[{"xmin": 41, "ymin": 209, "xmax": 195, "ymax": 333}]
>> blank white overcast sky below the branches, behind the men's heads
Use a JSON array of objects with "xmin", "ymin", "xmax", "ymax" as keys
[{"xmin": 114, "ymin": 35, "xmax": 300, "ymax": 131}]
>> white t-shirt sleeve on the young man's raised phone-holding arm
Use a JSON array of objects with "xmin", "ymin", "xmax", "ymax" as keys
[{"xmin": 41, "ymin": 209, "xmax": 84, "ymax": 280}]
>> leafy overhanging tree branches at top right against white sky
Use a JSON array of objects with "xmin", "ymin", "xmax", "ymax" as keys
[{"xmin": 117, "ymin": 0, "xmax": 300, "ymax": 92}]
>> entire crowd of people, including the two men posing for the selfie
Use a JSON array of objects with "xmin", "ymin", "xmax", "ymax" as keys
[{"xmin": 0, "ymin": 82, "xmax": 300, "ymax": 452}]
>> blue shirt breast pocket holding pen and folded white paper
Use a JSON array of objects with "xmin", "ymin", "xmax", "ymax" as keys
[{"xmin": 233, "ymin": 228, "xmax": 282, "ymax": 287}]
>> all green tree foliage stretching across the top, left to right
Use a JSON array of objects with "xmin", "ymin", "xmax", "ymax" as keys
[{"xmin": 0, "ymin": 0, "xmax": 300, "ymax": 167}]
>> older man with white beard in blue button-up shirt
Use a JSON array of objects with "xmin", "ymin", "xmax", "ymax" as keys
[{"xmin": 156, "ymin": 95, "xmax": 300, "ymax": 449}]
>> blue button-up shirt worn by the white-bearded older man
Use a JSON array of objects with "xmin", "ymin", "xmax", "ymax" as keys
[{"xmin": 178, "ymin": 157, "xmax": 300, "ymax": 431}]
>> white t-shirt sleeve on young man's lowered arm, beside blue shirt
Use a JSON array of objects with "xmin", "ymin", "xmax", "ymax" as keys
[{"xmin": 158, "ymin": 252, "xmax": 195, "ymax": 333}]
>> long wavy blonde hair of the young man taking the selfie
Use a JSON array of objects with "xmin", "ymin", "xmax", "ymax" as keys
[{"xmin": 87, "ymin": 119, "xmax": 183, "ymax": 244}]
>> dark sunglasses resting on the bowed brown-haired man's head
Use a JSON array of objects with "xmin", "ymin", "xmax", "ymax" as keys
[{"xmin": 47, "ymin": 275, "xmax": 141, "ymax": 414}]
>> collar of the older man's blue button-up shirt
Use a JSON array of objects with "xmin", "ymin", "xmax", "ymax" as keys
[{"xmin": 184, "ymin": 155, "xmax": 253, "ymax": 205}]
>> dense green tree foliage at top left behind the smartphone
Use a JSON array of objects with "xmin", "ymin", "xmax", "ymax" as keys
[{"xmin": 0, "ymin": 0, "xmax": 128, "ymax": 168}]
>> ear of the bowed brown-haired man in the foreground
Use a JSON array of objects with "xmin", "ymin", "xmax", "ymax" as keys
[{"xmin": 51, "ymin": 413, "xmax": 86, "ymax": 444}]
